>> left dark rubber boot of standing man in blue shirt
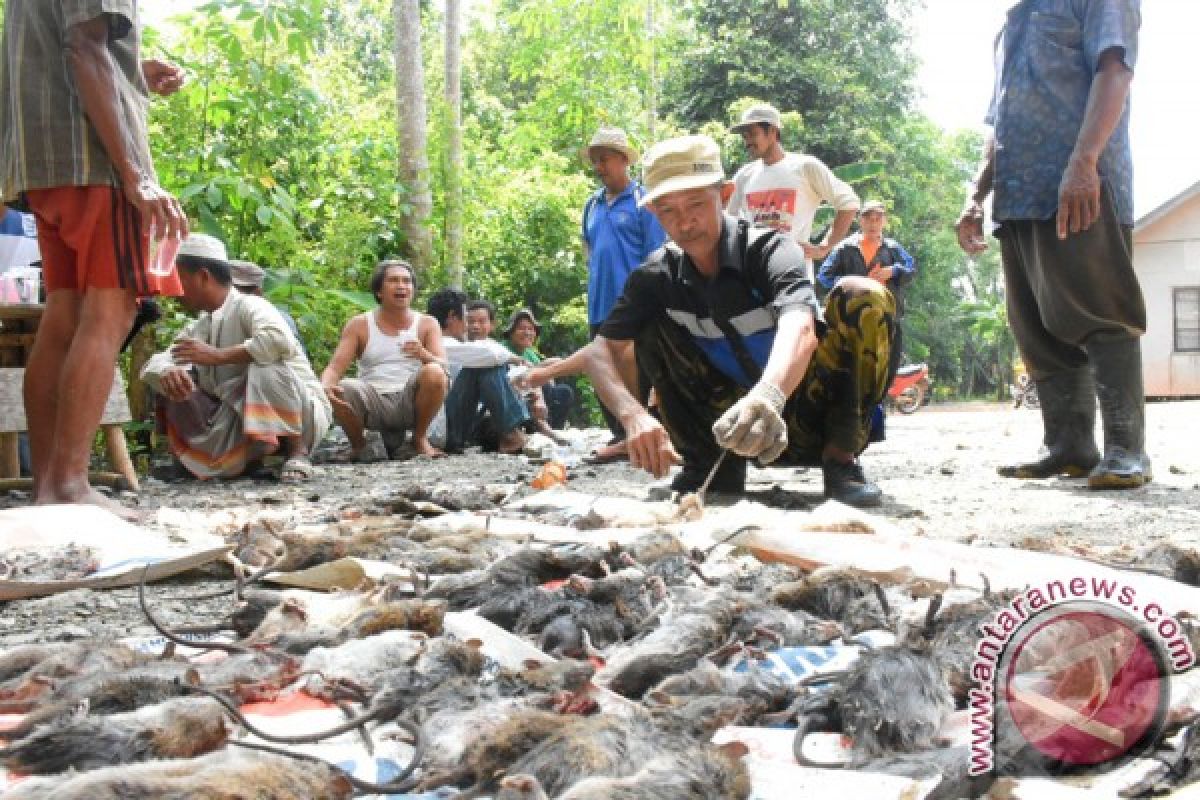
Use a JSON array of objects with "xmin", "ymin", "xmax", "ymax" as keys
[{"xmin": 996, "ymin": 366, "xmax": 1100, "ymax": 479}]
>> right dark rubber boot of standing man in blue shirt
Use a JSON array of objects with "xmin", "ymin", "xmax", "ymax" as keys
[{"xmin": 1084, "ymin": 339, "xmax": 1153, "ymax": 489}]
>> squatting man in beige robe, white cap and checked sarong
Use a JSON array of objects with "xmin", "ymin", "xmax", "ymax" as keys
[{"xmin": 142, "ymin": 234, "xmax": 332, "ymax": 481}]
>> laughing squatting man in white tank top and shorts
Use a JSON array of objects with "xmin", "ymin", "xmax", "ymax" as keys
[{"xmin": 320, "ymin": 260, "xmax": 450, "ymax": 459}]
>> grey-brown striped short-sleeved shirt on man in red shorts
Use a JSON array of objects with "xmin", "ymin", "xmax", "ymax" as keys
[{"xmin": 0, "ymin": 0, "xmax": 154, "ymax": 200}]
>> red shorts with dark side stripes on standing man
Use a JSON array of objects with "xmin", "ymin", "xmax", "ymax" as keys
[{"xmin": 26, "ymin": 186, "xmax": 184, "ymax": 297}]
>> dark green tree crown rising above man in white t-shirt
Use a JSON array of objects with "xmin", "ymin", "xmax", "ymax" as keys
[{"xmin": 664, "ymin": 0, "xmax": 916, "ymax": 164}]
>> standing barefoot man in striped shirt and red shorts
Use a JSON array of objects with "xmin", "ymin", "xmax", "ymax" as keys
[{"xmin": 0, "ymin": 0, "xmax": 187, "ymax": 513}]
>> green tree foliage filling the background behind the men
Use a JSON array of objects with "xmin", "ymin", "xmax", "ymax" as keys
[{"xmin": 126, "ymin": 0, "xmax": 1012, "ymax": 407}]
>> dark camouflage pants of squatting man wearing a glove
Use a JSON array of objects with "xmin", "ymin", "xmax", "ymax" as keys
[{"xmin": 637, "ymin": 284, "xmax": 895, "ymax": 468}]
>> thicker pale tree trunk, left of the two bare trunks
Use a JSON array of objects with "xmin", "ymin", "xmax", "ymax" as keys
[{"xmin": 392, "ymin": 0, "xmax": 433, "ymax": 272}]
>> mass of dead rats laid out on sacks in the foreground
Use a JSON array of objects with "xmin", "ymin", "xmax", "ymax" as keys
[{"xmin": 0, "ymin": 460, "xmax": 1200, "ymax": 800}]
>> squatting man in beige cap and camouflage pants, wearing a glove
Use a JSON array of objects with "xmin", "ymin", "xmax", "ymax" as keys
[{"xmin": 528, "ymin": 136, "xmax": 895, "ymax": 506}]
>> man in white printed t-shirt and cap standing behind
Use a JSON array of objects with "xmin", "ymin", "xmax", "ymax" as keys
[{"xmin": 726, "ymin": 103, "xmax": 859, "ymax": 277}]
